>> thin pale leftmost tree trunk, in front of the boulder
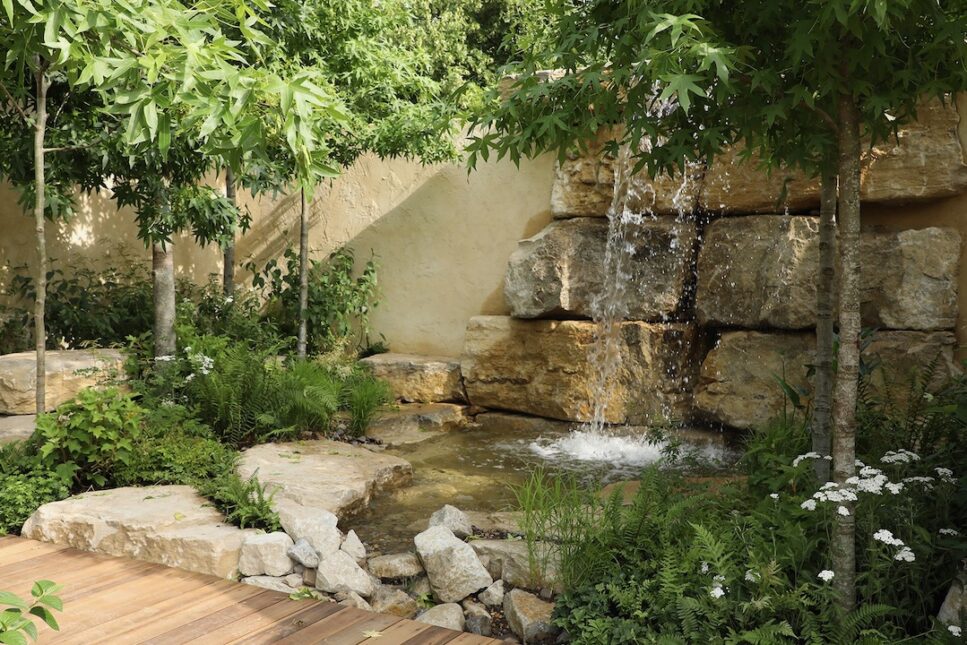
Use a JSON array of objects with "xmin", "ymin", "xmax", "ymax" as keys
[{"xmin": 34, "ymin": 63, "xmax": 49, "ymax": 414}]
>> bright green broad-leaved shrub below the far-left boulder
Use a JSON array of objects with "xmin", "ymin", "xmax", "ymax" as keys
[{"xmin": 36, "ymin": 388, "xmax": 144, "ymax": 488}]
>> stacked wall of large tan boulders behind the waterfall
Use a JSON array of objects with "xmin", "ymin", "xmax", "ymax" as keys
[{"xmin": 461, "ymin": 101, "xmax": 967, "ymax": 428}]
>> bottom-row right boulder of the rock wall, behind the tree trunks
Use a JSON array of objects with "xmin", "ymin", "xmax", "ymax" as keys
[{"xmin": 695, "ymin": 331, "xmax": 958, "ymax": 428}]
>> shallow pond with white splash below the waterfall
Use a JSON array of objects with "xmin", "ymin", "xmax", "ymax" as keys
[{"xmin": 346, "ymin": 413, "xmax": 739, "ymax": 553}]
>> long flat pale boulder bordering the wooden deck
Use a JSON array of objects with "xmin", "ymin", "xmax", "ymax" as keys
[{"xmin": 22, "ymin": 486, "xmax": 253, "ymax": 578}]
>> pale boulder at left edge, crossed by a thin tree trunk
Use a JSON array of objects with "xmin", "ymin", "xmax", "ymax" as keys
[{"xmin": 0, "ymin": 349, "xmax": 124, "ymax": 414}]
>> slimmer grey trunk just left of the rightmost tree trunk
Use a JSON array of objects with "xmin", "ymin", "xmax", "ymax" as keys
[{"xmin": 812, "ymin": 166, "xmax": 837, "ymax": 482}]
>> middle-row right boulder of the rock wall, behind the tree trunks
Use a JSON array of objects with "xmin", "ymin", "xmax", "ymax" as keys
[{"xmin": 695, "ymin": 215, "xmax": 961, "ymax": 330}]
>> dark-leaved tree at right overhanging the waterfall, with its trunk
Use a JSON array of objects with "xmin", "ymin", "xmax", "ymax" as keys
[{"xmin": 469, "ymin": 0, "xmax": 967, "ymax": 609}]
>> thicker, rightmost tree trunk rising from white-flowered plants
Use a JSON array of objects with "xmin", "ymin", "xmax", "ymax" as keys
[{"xmin": 832, "ymin": 95, "xmax": 860, "ymax": 611}]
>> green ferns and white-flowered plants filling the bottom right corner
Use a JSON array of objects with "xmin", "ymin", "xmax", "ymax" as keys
[{"xmin": 519, "ymin": 364, "xmax": 967, "ymax": 644}]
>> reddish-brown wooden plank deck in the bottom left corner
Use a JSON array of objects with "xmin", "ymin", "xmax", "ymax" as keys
[{"xmin": 0, "ymin": 537, "xmax": 500, "ymax": 645}]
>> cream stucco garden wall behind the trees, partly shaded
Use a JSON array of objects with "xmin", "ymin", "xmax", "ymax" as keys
[{"xmin": 0, "ymin": 158, "xmax": 554, "ymax": 356}]
